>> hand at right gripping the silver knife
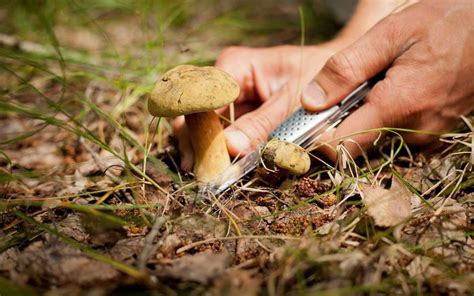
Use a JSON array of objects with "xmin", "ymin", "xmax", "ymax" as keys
[{"xmin": 302, "ymin": 0, "xmax": 474, "ymax": 160}]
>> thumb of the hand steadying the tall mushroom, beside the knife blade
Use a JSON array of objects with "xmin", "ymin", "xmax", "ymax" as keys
[{"xmin": 225, "ymin": 87, "xmax": 296, "ymax": 156}]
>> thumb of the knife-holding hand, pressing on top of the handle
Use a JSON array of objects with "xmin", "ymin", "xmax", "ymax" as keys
[{"xmin": 301, "ymin": 16, "xmax": 407, "ymax": 111}]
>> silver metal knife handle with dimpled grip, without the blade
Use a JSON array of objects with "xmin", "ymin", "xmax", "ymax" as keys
[{"xmin": 269, "ymin": 81, "xmax": 372, "ymax": 146}]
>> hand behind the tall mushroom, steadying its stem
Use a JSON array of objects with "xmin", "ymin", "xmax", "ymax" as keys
[{"xmin": 173, "ymin": 40, "xmax": 342, "ymax": 170}]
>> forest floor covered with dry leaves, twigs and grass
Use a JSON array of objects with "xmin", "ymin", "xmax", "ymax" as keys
[{"xmin": 0, "ymin": 0, "xmax": 474, "ymax": 296}]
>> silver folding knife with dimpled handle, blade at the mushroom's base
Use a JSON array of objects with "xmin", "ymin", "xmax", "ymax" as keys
[{"xmin": 200, "ymin": 79, "xmax": 378, "ymax": 195}]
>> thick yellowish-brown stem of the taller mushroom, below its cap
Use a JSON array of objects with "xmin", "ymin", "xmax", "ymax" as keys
[{"xmin": 185, "ymin": 111, "xmax": 230, "ymax": 182}]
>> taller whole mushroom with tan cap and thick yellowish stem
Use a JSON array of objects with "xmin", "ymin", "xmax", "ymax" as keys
[{"xmin": 148, "ymin": 65, "xmax": 240, "ymax": 182}]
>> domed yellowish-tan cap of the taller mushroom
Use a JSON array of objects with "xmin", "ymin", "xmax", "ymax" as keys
[{"xmin": 148, "ymin": 65, "xmax": 240, "ymax": 117}]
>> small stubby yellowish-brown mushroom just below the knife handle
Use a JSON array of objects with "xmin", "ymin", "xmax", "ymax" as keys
[{"xmin": 262, "ymin": 139, "xmax": 311, "ymax": 175}]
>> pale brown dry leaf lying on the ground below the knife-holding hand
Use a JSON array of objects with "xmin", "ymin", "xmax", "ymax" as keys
[{"xmin": 361, "ymin": 179, "xmax": 411, "ymax": 227}]
